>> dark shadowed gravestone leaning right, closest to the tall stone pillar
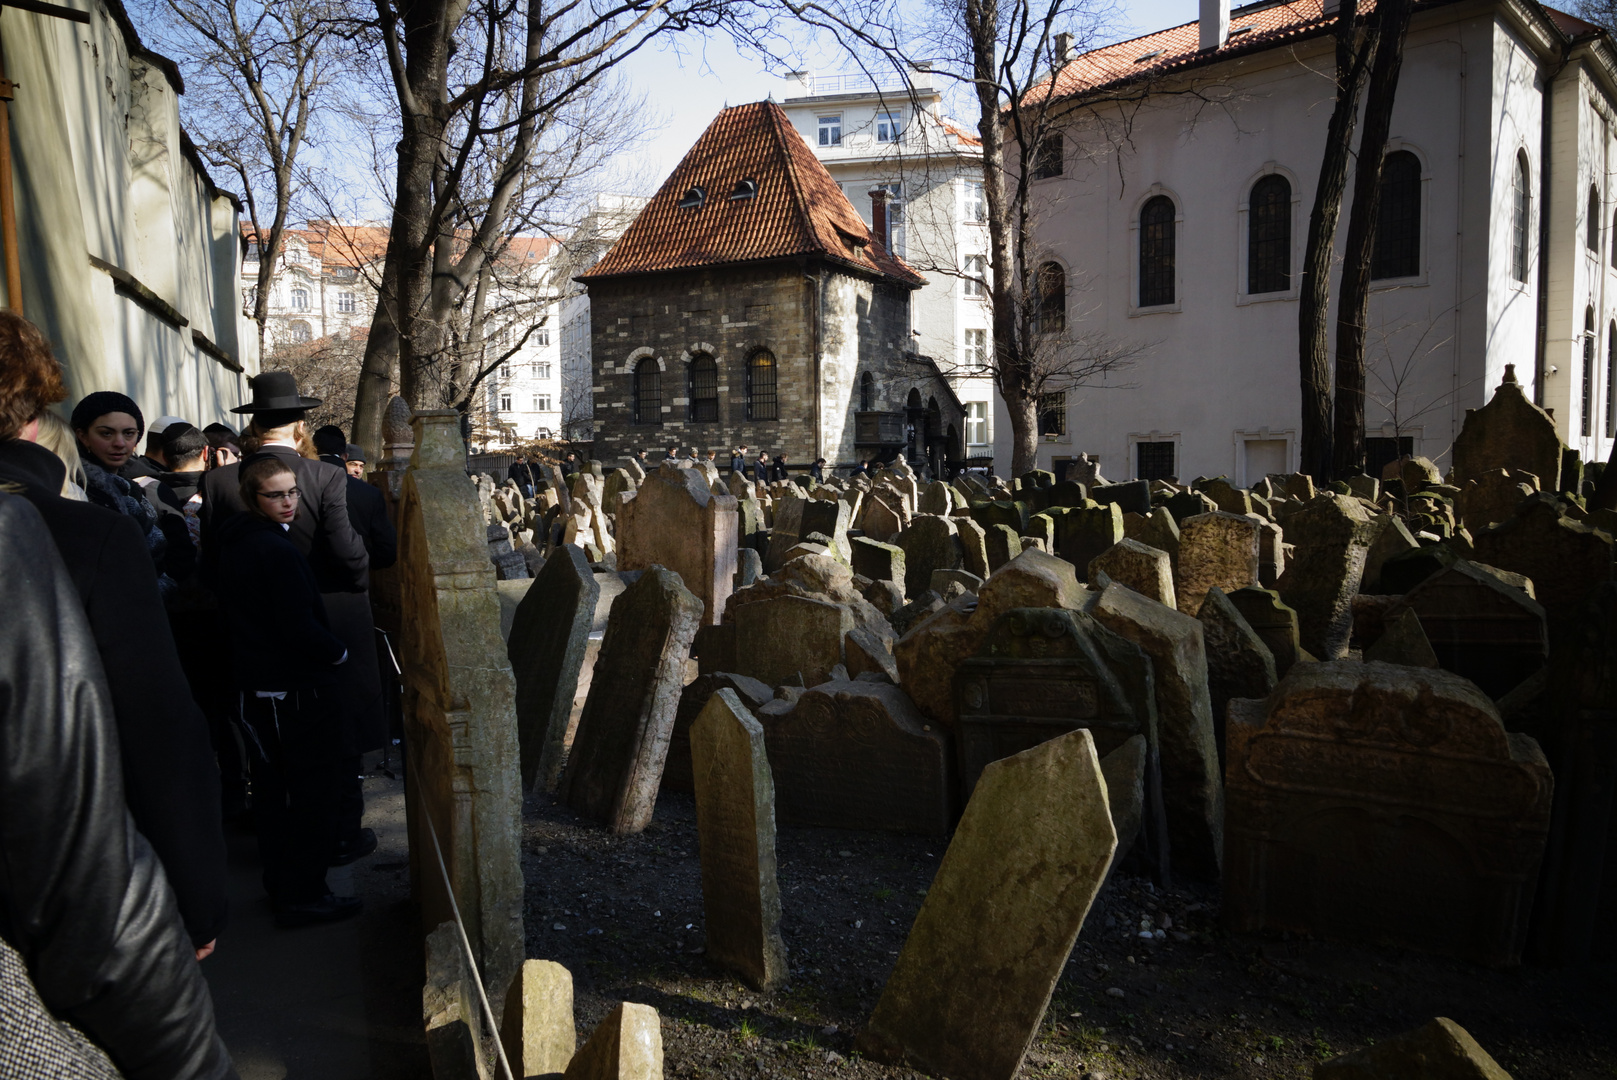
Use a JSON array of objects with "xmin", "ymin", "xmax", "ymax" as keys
[{"xmin": 506, "ymin": 543, "xmax": 602, "ymax": 791}]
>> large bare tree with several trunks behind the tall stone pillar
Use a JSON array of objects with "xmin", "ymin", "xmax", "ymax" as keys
[{"xmin": 354, "ymin": 0, "xmax": 740, "ymax": 446}]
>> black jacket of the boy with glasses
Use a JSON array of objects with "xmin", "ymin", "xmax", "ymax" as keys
[{"xmin": 215, "ymin": 514, "xmax": 348, "ymax": 694}]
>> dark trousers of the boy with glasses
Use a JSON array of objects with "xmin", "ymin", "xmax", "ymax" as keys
[{"xmin": 241, "ymin": 689, "xmax": 348, "ymax": 904}]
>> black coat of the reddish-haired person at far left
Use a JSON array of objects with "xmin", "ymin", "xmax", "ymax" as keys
[{"xmin": 0, "ymin": 440, "xmax": 226, "ymax": 944}]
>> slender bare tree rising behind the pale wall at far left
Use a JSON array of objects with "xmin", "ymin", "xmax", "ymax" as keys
[{"xmin": 131, "ymin": 0, "xmax": 349, "ymax": 354}]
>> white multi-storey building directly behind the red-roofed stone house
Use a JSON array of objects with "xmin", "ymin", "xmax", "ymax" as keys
[{"xmin": 781, "ymin": 71, "xmax": 1009, "ymax": 461}]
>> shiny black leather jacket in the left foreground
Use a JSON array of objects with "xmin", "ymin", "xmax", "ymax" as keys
[{"xmin": 0, "ymin": 491, "xmax": 234, "ymax": 1080}]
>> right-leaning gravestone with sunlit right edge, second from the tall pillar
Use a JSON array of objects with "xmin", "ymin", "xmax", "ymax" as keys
[{"xmin": 558, "ymin": 566, "xmax": 702, "ymax": 836}]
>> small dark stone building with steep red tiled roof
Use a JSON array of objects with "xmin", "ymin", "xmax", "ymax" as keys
[{"xmin": 577, "ymin": 102, "xmax": 964, "ymax": 467}]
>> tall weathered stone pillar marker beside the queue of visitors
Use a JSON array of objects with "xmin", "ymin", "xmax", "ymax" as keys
[{"xmin": 398, "ymin": 409, "xmax": 522, "ymax": 1007}]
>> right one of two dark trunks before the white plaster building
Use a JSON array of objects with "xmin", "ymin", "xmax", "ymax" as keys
[{"xmin": 1332, "ymin": 0, "xmax": 1413, "ymax": 480}]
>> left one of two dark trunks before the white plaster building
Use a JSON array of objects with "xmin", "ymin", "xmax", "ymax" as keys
[{"xmin": 1297, "ymin": 3, "xmax": 1374, "ymax": 479}]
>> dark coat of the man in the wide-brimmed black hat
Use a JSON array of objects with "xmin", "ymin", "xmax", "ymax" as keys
[{"xmin": 202, "ymin": 445, "xmax": 369, "ymax": 592}]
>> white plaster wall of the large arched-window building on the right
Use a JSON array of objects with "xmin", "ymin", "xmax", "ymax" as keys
[{"xmin": 996, "ymin": 10, "xmax": 1538, "ymax": 482}]
